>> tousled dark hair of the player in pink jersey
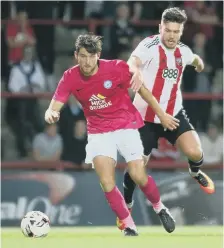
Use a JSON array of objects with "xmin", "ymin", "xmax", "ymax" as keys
[{"xmin": 75, "ymin": 34, "xmax": 102, "ymax": 54}]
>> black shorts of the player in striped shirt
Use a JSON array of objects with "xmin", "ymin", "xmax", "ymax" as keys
[{"xmin": 139, "ymin": 109, "xmax": 194, "ymax": 156}]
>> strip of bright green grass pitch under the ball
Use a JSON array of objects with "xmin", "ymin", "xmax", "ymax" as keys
[{"xmin": 1, "ymin": 226, "xmax": 223, "ymax": 248}]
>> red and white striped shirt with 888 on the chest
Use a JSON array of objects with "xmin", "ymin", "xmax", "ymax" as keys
[{"xmin": 132, "ymin": 35, "xmax": 194, "ymax": 123}]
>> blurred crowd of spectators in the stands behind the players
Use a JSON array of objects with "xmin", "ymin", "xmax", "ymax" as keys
[{"xmin": 1, "ymin": 1, "xmax": 223, "ymax": 168}]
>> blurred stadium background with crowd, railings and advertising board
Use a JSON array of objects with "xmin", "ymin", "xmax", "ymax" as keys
[{"xmin": 1, "ymin": 1, "xmax": 223, "ymax": 229}]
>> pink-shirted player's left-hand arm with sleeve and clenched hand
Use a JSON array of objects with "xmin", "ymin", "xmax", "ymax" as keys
[{"xmin": 45, "ymin": 72, "xmax": 71, "ymax": 124}]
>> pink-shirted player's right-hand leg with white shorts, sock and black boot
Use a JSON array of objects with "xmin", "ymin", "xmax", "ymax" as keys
[{"xmin": 118, "ymin": 130, "xmax": 175, "ymax": 232}]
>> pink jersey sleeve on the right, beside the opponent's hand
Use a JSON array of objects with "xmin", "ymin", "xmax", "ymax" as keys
[{"xmin": 117, "ymin": 60, "xmax": 132, "ymax": 88}]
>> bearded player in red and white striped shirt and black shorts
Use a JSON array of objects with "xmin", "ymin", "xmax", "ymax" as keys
[{"xmin": 117, "ymin": 8, "xmax": 215, "ymax": 232}]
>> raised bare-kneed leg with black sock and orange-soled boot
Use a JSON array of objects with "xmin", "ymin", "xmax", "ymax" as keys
[{"xmin": 176, "ymin": 130, "xmax": 215, "ymax": 194}]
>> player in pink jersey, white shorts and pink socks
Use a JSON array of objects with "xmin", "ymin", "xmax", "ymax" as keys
[{"xmin": 45, "ymin": 34, "xmax": 179, "ymax": 236}]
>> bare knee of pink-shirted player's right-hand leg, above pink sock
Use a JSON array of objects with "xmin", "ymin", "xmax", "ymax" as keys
[{"xmin": 128, "ymin": 160, "xmax": 148, "ymax": 186}]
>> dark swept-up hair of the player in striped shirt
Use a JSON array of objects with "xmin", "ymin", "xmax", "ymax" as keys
[{"xmin": 162, "ymin": 7, "xmax": 187, "ymax": 24}]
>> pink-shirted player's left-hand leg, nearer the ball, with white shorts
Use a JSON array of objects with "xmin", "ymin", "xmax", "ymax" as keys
[{"xmin": 86, "ymin": 133, "xmax": 137, "ymax": 236}]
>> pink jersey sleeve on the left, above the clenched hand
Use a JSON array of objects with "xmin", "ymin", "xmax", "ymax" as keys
[{"xmin": 53, "ymin": 71, "xmax": 71, "ymax": 103}]
